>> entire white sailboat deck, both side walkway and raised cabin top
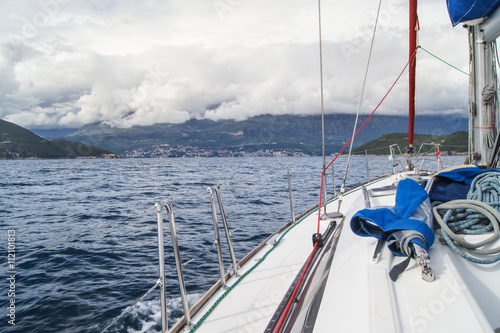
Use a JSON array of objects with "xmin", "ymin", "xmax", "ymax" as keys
[{"xmin": 186, "ymin": 174, "xmax": 500, "ymax": 332}]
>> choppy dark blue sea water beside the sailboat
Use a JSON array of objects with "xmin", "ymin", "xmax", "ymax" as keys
[{"xmin": 0, "ymin": 157, "xmax": 463, "ymax": 332}]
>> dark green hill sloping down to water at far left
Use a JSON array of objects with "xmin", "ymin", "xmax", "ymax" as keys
[{"xmin": 0, "ymin": 119, "xmax": 118, "ymax": 159}]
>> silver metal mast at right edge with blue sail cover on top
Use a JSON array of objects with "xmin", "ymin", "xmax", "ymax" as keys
[{"xmin": 447, "ymin": 0, "xmax": 500, "ymax": 168}]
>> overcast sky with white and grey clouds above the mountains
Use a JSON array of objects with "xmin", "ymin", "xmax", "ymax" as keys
[{"xmin": 0, "ymin": 0, "xmax": 468, "ymax": 129}]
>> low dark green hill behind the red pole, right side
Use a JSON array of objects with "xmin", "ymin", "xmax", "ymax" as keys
[{"xmin": 353, "ymin": 131, "xmax": 467, "ymax": 155}]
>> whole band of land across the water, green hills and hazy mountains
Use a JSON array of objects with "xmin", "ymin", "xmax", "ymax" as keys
[{"xmin": 0, "ymin": 114, "xmax": 467, "ymax": 159}]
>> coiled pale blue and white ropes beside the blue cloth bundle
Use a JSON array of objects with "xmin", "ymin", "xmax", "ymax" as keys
[{"xmin": 433, "ymin": 172, "xmax": 500, "ymax": 264}]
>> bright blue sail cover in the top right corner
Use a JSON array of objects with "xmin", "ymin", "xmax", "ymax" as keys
[{"xmin": 446, "ymin": 0, "xmax": 500, "ymax": 26}]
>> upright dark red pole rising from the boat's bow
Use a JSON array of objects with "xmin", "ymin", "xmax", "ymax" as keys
[{"xmin": 408, "ymin": 0, "xmax": 418, "ymax": 150}]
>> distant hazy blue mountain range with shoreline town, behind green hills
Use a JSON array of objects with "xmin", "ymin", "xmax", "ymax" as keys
[{"xmin": 66, "ymin": 114, "xmax": 467, "ymax": 157}]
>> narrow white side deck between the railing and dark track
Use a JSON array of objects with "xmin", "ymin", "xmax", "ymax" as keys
[{"xmin": 189, "ymin": 191, "xmax": 327, "ymax": 333}]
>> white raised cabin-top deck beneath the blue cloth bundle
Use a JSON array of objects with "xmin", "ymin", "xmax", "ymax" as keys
[{"xmin": 315, "ymin": 174, "xmax": 500, "ymax": 332}]
